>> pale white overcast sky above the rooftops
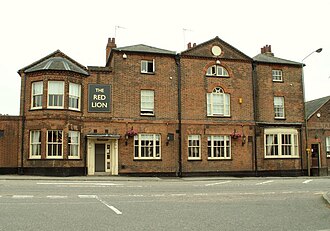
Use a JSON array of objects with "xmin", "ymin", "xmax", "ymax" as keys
[{"xmin": 0, "ymin": 0, "xmax": 330, "ymax": 115}]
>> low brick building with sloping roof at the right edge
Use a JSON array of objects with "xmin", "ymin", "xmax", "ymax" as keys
[{"xmin": 306, "ymin": 96, "xmax": 330, "ymax": 176}]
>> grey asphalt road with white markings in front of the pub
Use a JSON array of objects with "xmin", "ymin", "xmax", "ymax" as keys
[{"xmin": 0, "ymin": 178, "xmax": 330, "ymax": 231}]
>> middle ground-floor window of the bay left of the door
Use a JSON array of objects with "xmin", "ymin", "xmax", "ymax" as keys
[{"xmin": 47, "ymin": 130, "xmax": 63, "ymax": 158}]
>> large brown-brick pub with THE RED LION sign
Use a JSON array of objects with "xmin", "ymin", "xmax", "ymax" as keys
[{"xmin": 0, "ymin": 37, "xmax": 314, "ymax": 176}]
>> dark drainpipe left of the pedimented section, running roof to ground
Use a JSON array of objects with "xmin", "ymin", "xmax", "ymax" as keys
[{"xmin": 175, "ymin": 54, "xmax": 182, "ymax": 177}]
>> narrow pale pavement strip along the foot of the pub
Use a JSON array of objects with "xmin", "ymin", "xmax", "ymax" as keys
[{"xmin": 0, "ymin": 175, "xmax": 330, "ymax": 205}]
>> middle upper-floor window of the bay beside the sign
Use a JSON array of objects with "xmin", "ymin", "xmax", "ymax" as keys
[{"xmin": 48, "ymin": 81, "xmax": 64, "ymax": 108}]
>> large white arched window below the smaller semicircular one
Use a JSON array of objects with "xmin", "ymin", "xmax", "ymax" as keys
[{"xmin": 207, "ymin": 87, "xmax": 230, "ymax": 116}]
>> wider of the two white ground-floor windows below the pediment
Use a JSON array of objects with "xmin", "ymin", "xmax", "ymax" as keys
[{"xmin": 207, "ymin": 136, "xmax": 231, "ymax": 160}]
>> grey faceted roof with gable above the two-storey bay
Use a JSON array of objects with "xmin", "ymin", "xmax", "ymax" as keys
[{"xmin": 19, "ymin": 50, "xmax": 89, "ymax": 75}]
